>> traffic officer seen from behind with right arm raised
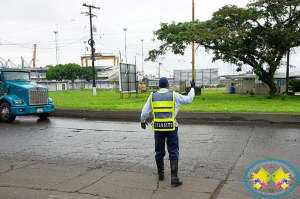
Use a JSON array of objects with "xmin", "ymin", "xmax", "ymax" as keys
[{"xmin": 141, "ymin": 77, "xmax": 195, "ymax": 186}]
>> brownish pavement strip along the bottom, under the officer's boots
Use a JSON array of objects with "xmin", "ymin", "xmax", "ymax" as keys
[{"xmin": 0, "ymin": 159, "xmax": 240, "ymax": 199}]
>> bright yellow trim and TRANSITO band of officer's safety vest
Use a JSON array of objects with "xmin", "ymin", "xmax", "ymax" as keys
[{"xmin": 150, "ymin": 91, "xmax": 176, "ymax": 131}]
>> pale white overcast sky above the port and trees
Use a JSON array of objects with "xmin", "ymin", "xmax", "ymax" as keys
[{"xmin": 0, "ymin": 0, "xmax": 300, "ymax": 77}]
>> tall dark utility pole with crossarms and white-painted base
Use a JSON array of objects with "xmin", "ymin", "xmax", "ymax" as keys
[{"xmin": 81, "ymin": 3, "xmax": 100, "ymax": 96}]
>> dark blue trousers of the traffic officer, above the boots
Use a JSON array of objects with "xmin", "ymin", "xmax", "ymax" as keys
[{"xmin": 154, "ymin": 127, "xmax": 179, "ymax": 160}]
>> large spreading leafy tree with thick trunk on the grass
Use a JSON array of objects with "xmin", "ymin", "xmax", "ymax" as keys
[{"xmin": 146, "ymin": 0, "xmax": 300, "ymax": 96}]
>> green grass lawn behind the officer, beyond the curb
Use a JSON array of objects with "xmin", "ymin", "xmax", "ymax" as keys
[{"xmin": 49, "ymin": 89, "xmax": 300, "ymax": 114}]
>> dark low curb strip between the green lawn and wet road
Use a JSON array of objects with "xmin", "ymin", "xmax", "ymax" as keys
[{"xmin": 51, "ymin": 109, "xmax": 300, "ymax": 124}]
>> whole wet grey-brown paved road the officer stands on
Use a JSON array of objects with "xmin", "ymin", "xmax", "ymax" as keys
[{"xmin": 0, "ymin": 117, "xmax": 300, "ymax": 199}]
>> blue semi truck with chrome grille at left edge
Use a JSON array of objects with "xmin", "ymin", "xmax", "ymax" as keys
[{"xmin": 0, "ymin": 68, "xmax": 55, "ymax": 122}]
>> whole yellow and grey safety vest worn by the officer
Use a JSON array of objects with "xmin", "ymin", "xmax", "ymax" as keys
[{"xmin": 150, "ymin": 91, "xmax": 175, "ymax": 131}]
